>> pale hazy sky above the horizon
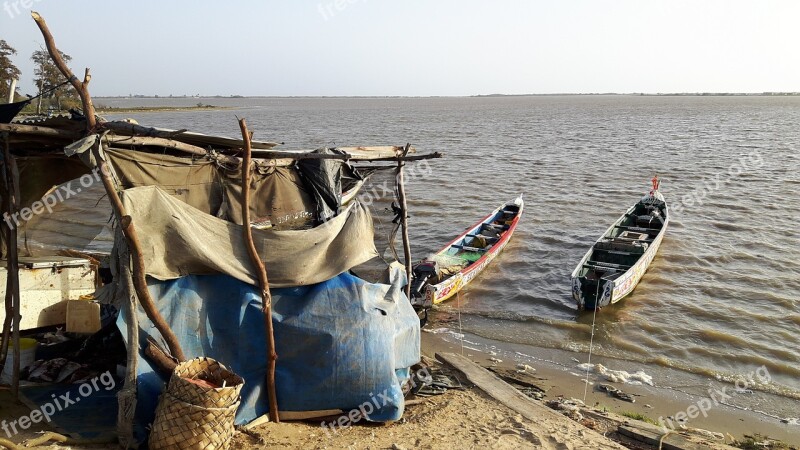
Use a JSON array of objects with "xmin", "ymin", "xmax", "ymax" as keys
[{"xmin": 0, "ymin": 0, "xmax": 800, "ymax": 96}]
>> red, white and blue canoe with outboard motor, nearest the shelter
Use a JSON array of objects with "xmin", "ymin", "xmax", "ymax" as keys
[{"xmin": 411, "ymin": 195, "xmax": 524, "ymax": 308}]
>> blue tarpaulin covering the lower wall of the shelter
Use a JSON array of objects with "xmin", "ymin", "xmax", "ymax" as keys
[{"xmin": 118, "ymin": 270, "xmax": 420, "ymax": 440}]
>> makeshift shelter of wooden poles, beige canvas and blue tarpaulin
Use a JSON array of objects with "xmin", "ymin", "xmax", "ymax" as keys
[{"xmin": 0, "ymin": 13, "xmax": 440, "ymax": 447}]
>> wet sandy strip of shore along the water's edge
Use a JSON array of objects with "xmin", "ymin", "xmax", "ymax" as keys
[{"xmin": 422, "ymin": 328, "xmax": 800, "ymax": 446}]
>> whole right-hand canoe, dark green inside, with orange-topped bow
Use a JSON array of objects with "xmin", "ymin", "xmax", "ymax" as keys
[{"xmin": 572, "ymin": 177, "xmax": 669, "ymax": 311}]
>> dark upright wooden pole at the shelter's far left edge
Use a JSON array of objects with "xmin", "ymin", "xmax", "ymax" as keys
[{"xmin": 3, "ymin": 133, "xmax": 21, "ymax": 398}]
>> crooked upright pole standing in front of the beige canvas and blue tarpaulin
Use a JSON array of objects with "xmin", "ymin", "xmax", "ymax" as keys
[{"xmin": 239, "ymin": 119, "xmax": 280, "ymax": 422}]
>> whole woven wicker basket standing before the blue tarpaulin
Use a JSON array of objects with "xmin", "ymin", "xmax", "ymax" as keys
[{"xmin": 148, "ymin": 358, "xmax": 244, "ymax": 450}]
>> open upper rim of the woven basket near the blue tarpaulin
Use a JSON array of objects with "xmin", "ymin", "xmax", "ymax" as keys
[{"xmin": 167, "ymin": 358, "xmax": 244, "ymax": 408}]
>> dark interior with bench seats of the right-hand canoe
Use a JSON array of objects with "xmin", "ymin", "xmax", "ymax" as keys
[{"xmin": 579, "ymin": 198, "xmax": 666, "ymax": 305}]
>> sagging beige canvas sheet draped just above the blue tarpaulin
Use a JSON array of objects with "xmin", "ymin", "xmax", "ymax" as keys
[{"xmin": 122, "ymin": 186, "xmax": 378, "ymax": 287}]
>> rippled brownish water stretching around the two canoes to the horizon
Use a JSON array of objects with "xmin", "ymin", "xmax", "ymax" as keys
[{"xmin": 101, "ymin": 96, "xmax": 800, "ymax": 404}]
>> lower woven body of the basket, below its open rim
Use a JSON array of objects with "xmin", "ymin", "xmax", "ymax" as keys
[{"xmin": 148, "ymin": 392, "xmax": 239, "ymax": 450}]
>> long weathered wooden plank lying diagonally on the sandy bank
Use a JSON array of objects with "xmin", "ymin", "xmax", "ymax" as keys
[{"xmin": 436, "ymin": 353, "xmax": 624, "ymax": 449}]
